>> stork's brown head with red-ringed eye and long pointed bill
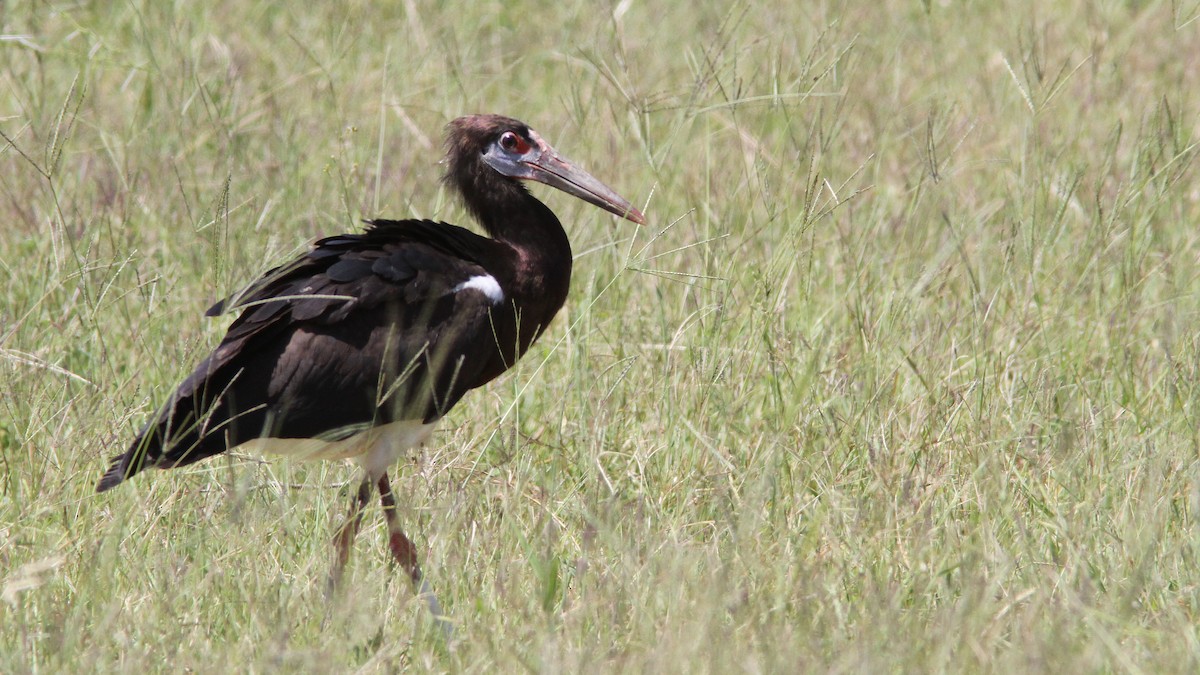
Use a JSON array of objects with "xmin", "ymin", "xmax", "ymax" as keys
[{"xmin": 446, "ymin": 115, "xmax": 646, "ymax": 223}]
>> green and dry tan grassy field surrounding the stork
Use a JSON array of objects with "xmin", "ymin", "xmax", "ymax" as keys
[{"xmin": 0, "ymin": 0, "xmax": 1200, "ymax": 673}]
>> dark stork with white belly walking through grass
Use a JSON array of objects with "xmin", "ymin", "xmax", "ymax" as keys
[{"xmin": 96, "ymin": 115, "xmax": 644, "ymax": 616}]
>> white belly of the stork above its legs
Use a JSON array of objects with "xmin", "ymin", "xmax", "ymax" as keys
[{"xmin": 238, "ymin": 420, "xmax": 437, "ymax": 478}]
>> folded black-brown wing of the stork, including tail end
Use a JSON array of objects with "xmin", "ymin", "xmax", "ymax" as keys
[{"xmin": 97, "ymin": 221, "xmax": 516, "ymax": 491}]
